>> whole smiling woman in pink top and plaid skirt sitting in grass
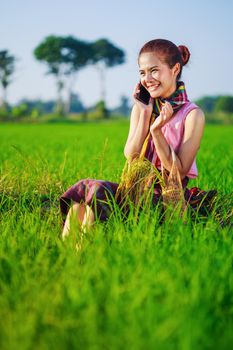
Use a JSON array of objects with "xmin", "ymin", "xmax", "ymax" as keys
[{"xmin": 61, "ymin": 39, "xmax": 205, "ymax": 238}]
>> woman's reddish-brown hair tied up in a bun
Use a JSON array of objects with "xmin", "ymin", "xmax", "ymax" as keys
[{"xmin": 138, "ymin": 39, "xmax": 190, "ymax": 80}]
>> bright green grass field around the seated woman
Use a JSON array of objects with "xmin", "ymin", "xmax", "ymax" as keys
[{"xmin": 0, "ymin": 121, "xmax": 233, "ymax": 350}]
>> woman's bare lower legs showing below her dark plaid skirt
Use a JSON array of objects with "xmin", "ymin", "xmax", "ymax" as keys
[{"xmin": 62, "ymin": 203, "xmax": 95, "ymax": 240}]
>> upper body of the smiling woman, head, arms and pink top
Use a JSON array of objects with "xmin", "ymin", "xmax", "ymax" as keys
[{"xmin": 125, "ymin": 39, "xmax": 204, "ymax": 178}]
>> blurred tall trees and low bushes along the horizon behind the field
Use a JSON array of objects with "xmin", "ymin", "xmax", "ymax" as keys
[{"xmin": 0, "ymin": 35, "xmax": 233, "ymax": 122}]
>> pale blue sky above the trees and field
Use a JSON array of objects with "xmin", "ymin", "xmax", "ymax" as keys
[{"xmin": 0, "ymin": 0, "xmax": 233, "ymax": 107}]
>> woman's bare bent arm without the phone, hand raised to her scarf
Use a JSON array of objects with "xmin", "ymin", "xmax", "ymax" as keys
[{"xmin": 150, "ymin": 108, "xmax": 205, "ymax": 179}]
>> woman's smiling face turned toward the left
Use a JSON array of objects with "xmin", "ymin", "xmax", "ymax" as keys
[{"xmin": 139, "ymin": 52, "xmax": 180, "ymax": 98}]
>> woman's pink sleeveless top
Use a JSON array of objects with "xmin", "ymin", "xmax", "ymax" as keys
[{"xmin": 145, "ymin": 102, "xmax": 199, "ymax": 178}]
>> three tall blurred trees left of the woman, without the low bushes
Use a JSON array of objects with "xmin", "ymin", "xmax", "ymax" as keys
[{"xmin": 0, "ymin": 35, "xmax": 125, "ymax": 115}]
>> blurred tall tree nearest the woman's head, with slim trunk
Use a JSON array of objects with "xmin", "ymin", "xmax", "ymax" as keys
[{"xmin": 92, "ymin": 39, "xmax": 125, "ymax": 105}]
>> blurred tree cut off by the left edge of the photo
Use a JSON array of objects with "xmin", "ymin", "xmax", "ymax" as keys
[{"xmin": 0, "ymin": 50, "xmax": 16, "ymax": 106}]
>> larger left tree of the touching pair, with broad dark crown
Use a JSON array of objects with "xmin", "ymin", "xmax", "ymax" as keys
[{"xmin": 34, "ymin": 35, "xmax": 91, "ymax": 113}]
